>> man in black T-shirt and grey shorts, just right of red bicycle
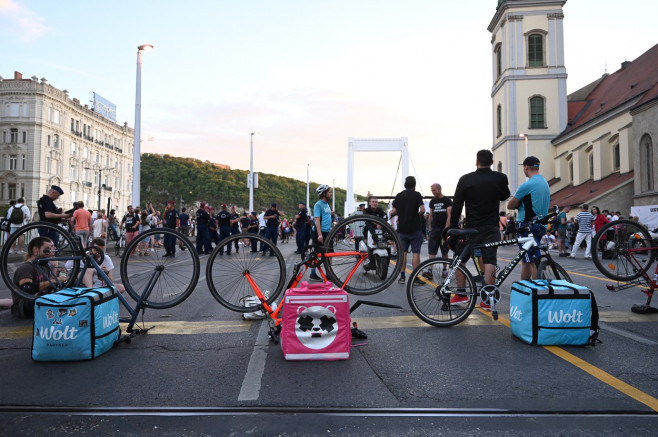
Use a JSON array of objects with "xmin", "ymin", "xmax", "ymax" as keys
[{"xmin": 391, "ymin": 176, "xmax": 425, "ymax": 284}]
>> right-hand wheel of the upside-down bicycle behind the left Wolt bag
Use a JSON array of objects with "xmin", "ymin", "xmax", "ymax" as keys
[{"xmin": 121, "ymin": 228, "xmax": 201, "ymax": 309}]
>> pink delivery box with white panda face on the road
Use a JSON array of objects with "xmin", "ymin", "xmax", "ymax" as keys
[{"xmin": 281, "ymin": 282, "xmax": 352, "ymax": 360}]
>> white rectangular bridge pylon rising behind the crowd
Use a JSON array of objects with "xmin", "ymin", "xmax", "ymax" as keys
[{"xmin": 345, "ymin": 137, "xmax": 409, "ymax": 216}]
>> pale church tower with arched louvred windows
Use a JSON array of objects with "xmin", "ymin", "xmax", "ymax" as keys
[{"xmin": 488, "ymin": 0, "xmax": 567, "ymax": 193}]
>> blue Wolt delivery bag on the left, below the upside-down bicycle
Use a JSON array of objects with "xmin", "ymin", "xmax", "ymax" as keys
[{"xmin": 32, "ymin": 287, "xmax": 119, "ymax": 361}]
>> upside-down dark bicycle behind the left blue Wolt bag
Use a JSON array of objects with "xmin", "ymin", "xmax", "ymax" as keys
[{"xmin": 0, "ymin": 222, "xmax": 200, "ymax": 338}]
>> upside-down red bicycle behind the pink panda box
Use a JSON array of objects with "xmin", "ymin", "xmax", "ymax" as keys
[{"xmin": 206, "ymin": 215, "xmax": 403, "ymax": 341}]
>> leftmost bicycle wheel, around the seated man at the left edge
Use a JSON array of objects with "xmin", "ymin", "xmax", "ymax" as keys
[{"xmin": 0, "ymin": 222, "xmax": 82, "ymax": 300}]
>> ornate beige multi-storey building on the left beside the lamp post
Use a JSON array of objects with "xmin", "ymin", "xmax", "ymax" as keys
[{"xmin": 0, "ymin": 72, "xmax": 134, "ymax": 218}]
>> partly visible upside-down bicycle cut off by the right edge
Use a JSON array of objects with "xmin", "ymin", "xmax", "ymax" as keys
[{"xmin": 592, "ymin": 220, "xmax": 658, "ymax": 314}]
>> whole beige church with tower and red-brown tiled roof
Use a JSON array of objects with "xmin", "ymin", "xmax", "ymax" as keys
[{"xmin": 488, "ymin": 0, "xmax": 658, "ymax": 217}]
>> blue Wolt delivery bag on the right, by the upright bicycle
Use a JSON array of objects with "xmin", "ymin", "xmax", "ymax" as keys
[{"xmin": 510, "ymin": 279, "xmax": 599, "ymax": 346}]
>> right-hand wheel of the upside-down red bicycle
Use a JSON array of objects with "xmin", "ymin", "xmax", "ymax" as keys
[{"xmin": 324, "ymin": 215, "xmax": 404, "ymax": 296}]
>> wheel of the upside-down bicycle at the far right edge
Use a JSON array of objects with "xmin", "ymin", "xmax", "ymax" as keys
[{"xmin": 592, "ymin": 220, "xmax": 656, "ymax": 281}]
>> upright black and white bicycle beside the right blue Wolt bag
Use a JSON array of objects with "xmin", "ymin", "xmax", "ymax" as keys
[{"xmin": 407, "ymin": 212, "xmax": 571, "ymax": 327}]
